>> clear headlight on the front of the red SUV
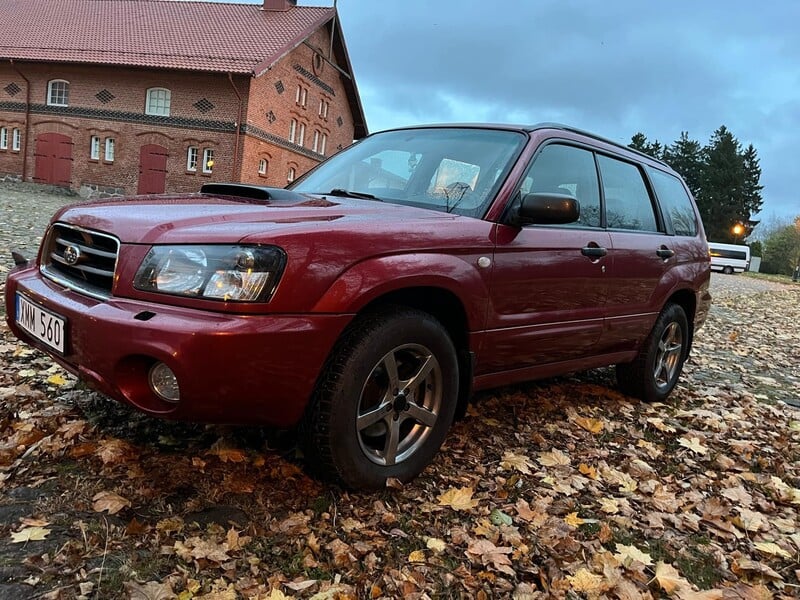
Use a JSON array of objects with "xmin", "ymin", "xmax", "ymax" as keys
[{"xmin": 133, "ymin": 246, "xmax": 286, "ymax": 302}]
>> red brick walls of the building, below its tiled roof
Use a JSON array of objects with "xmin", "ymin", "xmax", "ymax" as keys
[{"xmin": 0, "ymin": 22, "xmax": 360, "ymax": 195}]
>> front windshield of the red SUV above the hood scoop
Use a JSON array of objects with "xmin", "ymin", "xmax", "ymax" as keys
[{"xmin": 290, "ymin": 128, "xmax": 526, "ymax": 217}]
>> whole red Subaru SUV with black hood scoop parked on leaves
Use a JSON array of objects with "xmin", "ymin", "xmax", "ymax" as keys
[{"xmin": 6, "ymin": 124, "xmax": 710, "ymax": 487}]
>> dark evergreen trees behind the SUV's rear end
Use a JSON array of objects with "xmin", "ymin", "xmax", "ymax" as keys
[{"xmin": 628, "ymin": 125, "xmax": 764, "ymax": 244}]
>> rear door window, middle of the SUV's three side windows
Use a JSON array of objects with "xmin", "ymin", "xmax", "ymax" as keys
[{"xmin": 597, "ymin": 156, "xmax": 658, "ymax": 231}]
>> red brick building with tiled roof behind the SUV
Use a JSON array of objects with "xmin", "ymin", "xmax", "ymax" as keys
[{"xmin": 0, "ymin": 0, "xmax": 367, "ymax": 196}]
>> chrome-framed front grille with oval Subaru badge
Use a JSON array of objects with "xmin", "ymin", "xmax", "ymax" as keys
[{"xmin": 41, "ymin": 223, "xmax": 119, "ymax": 299}]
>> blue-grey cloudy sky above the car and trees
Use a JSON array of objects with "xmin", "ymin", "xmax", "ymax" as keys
[{"xmin": 251, "ymin": 0, "xmax": 800, "ymax": 221}]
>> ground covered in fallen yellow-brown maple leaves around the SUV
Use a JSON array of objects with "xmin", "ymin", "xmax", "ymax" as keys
[{"xmin": 0, "ymin": 276, "xmax": 800, "ymax": 599}]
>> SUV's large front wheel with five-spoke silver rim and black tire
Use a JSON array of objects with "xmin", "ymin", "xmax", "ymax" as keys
[{"xmin": 303, "ymin": 306, "xmax": 459, "ymax": 489}]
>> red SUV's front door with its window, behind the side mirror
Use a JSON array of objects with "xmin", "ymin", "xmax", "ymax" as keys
[{"xmin": 476, "ymin": 143, "xmax": 611, "ymax": 375}]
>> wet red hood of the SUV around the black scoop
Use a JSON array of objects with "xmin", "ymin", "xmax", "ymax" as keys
[{"xmin": 53, "ymin": 194, "xmax": 459, "ymax": 244}]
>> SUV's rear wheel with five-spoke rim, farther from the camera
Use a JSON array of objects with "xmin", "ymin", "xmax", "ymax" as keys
[{"xmin": 617, "ymin": 303, "xmax": 689, "ymax": 402}]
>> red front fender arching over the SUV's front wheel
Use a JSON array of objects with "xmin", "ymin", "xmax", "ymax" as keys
[{"xmin": 312, "ymin": 253, "xmax": 491, "ymax": 331}]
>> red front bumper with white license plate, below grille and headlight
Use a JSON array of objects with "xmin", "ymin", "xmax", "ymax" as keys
[{"xmin": 5, "ymin": 266, "xmax": 353, "ymax": 427}]
